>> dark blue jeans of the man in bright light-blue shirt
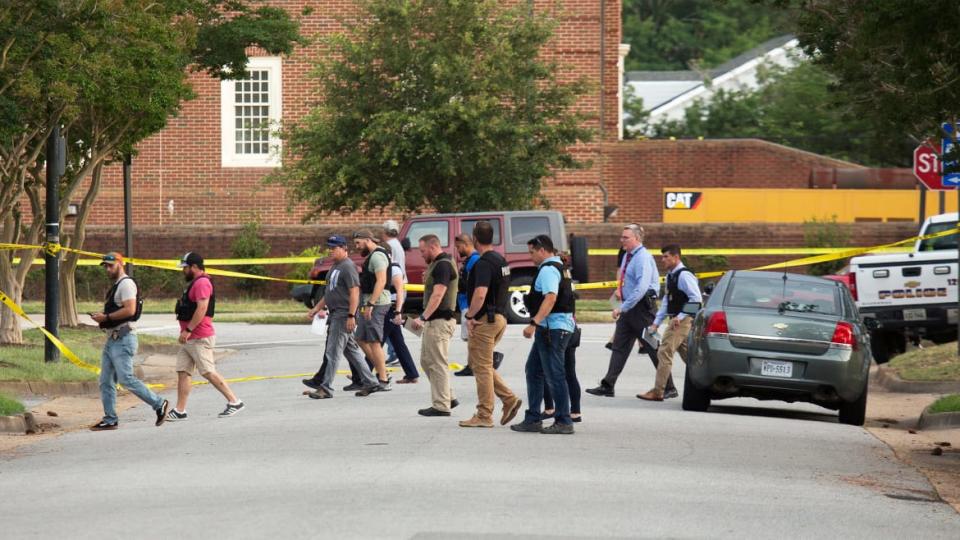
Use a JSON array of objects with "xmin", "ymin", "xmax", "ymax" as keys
[{"xmin": 524, "ymin": 326, "xmax": 573, "ymax": 424}]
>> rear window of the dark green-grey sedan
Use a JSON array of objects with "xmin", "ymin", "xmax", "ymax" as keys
[{"xmin": 726, "ymin": 277, "xmax": 841, "ymax": 315}]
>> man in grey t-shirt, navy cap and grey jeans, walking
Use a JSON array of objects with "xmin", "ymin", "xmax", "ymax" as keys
[{"xmin": 303, "ymin": 236, "xmax": 380, "ymax": 399}]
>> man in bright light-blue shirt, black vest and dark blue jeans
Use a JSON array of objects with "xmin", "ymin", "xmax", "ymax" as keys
[{"xmin": 510, "ymin": 234, "xmax": 575, "ymax": 435}]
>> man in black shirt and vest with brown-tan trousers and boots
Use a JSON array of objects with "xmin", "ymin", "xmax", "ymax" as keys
[{"xmin": 460, "ymin": 221, "xmax": 523, "ymax": 427}]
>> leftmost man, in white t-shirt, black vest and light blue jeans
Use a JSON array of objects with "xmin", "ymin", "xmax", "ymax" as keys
[{"xmin": 90, "ymin": 253, "xmax": 169, "ymax": 431}]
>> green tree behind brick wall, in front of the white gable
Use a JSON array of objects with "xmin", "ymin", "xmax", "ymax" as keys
[{"xmin": 640, "ymin": 62, "xmax": 912, "ymax": 167}]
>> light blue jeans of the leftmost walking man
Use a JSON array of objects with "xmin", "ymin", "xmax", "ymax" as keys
[{"xmin": 100, "ymin": 334, "xmax": 163, "ymax": 424}]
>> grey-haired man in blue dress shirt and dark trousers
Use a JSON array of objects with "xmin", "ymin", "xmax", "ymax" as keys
[{"xmin": 587, "ymin": 224, "xmax": 660, "ymax": 397}]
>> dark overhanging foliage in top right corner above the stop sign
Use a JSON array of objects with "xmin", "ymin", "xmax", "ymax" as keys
[{"xmin": 770, "ymin": 0, "xmax": 960, "ymax": 144}]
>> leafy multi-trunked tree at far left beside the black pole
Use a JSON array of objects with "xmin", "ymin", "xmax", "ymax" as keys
[{"xmin": 0, "ymin": 0, "xmax": 299, "ymax": 343}]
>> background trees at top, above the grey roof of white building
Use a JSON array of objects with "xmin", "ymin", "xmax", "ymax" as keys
[{"xmin": 623, "ymin": 0, "xmax": 790, "ymax": 71}]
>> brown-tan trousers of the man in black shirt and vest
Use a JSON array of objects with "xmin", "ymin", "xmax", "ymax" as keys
[{"xmin": 467, "ymin": 315, "xmax": 517, "ymax": 421}]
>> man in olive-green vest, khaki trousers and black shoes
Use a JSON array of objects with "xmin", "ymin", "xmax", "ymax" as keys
[{"xmin": 413, "ymin": 234, "xmax": 459, "ymax": 416}]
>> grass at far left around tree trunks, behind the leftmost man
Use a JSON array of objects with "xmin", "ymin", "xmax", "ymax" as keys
[{"xmin": 0, "ymin": 327, "xmax": 176, "ymax": 382}]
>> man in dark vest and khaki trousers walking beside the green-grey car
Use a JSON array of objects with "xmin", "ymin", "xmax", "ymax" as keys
[{"xmin": 637, "ymin": 244, "xmax": 703, "ymax": 401}]
